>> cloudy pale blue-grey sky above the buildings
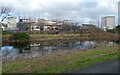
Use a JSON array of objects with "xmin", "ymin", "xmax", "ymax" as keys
[{"xmin": 0, "ymin": 0, "xmax": 119, "ymax": 25}]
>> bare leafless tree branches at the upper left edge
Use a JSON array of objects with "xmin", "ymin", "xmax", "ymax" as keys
[{"xmin": 0, "ymin": 5, "xmax": 13, "ymax": 22}]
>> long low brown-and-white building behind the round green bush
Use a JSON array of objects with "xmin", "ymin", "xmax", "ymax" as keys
[{"xmin": 17, "ymin": 18, "xmax": 58, "ymax": 34}]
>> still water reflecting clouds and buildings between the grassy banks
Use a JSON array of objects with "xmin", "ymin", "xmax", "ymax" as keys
[{"xmin": 0, "ymin": 41, "xmax": 116, "ymax": 61}]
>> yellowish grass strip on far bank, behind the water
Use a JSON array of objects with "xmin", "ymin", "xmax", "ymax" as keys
[{"xmin": 2, "ymin": 34, "xmax": 118, "ymax": 42}]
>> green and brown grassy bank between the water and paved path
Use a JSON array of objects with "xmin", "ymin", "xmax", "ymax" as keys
[{"xmin": 3, "ymin": 46, "xmax": 118, "ymax": 73}]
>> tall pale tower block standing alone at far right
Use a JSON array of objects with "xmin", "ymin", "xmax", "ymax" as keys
[{"xmin": 101, "ymin": 16, "xmax": 115, "ymax": 31}]
